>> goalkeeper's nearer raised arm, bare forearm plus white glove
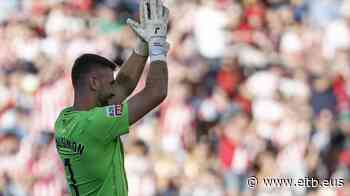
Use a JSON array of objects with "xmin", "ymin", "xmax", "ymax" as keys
[{"xmin": 109, "ymin": 0, "xmax": 169, "ymax": 125}]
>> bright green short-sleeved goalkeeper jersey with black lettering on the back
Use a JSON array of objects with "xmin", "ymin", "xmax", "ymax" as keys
[{"xmin": 55, "ymin": 103, "xmax": 129, "ymax": 196}]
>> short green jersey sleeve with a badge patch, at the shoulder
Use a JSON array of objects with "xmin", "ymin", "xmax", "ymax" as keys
[{"xmin": 88, "ymin": 102, "xmax": 129, "ymax": 140}]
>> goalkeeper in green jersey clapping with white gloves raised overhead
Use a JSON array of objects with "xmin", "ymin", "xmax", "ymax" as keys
[{"xmin": 55, "ymin": 0, "xmax": 169, "ymax": 196}]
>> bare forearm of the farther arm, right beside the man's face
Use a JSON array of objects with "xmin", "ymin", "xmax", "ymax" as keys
[{"xmin": 110, "ymin": 51, "xmax": 147, "ymax": 103}]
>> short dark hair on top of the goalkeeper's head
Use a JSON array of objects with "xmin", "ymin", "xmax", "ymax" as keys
[{"xmin": 71, "ymin": 53, "xmax": 117, "ymax": 88}]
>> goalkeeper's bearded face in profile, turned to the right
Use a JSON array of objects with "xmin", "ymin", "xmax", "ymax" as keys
[{"xmin": 96, "ymin": 68, "xmax": 115, "ymax": 106}]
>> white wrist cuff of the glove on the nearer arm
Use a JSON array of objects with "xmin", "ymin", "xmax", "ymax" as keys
[{"xmin": 148, "ymin": 37, "xmax": 168, "ymax": 63}]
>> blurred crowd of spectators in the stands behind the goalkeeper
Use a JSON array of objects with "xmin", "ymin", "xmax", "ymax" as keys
[{"xmin": 0, "ymin": 0, "xmax": 350, "ymax": 196}]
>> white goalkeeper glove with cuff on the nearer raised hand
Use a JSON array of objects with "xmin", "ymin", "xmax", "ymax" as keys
[{"xmin": 127, "ymin": 0, "xmax": 169, "ymax": 62}]
